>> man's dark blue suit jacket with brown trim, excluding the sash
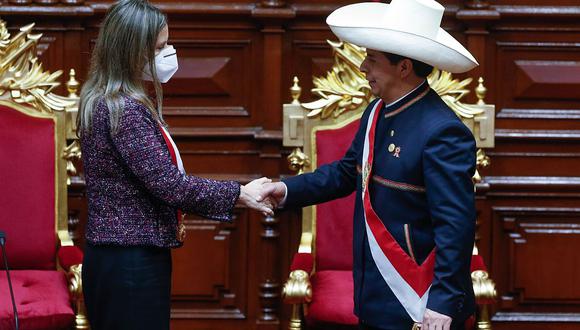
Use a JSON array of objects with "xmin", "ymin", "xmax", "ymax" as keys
[{"xmin": 284, "ymin": 82, "xmax": 476, "ymax": 329}]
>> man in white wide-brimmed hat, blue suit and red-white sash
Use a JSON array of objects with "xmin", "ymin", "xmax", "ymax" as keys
[{"xmin": 263, "ymin": 0, "xmax": 477, "ymax": 330}]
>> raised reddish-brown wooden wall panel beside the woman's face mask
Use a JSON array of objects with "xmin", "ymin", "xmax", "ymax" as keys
[{"xmin": 163, "ymin": 36, "xmax": 253, "ymax": 117}]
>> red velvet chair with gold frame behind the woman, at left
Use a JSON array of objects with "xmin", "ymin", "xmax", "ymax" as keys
[{"xmin": 0, "ymin": 21, "xmax": 88, "ymax": 330}]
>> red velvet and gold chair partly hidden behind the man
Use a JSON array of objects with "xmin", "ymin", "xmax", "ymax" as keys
[{"xmin": 283, "ymin": 42, "xmax": 495, "ymax": 329}]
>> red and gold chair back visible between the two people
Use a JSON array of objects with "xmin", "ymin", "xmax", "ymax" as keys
[{"xmin": 284, "ymin": 43, "xmax": 370, "ymax": 270}]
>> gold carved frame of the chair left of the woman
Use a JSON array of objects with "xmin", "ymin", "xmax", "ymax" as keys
[{"xmin": 0, "ymin": 20, "xmax": 89, "ymax": 329}]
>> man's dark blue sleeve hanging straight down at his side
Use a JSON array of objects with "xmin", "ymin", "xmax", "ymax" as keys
[{"xmin": 423, "ymin": 122, "xmax": 476, "ymax": 318}]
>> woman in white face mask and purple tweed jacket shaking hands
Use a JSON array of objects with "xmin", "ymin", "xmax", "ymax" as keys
[{"xmin": 78, "ymin": 0, "xmax": 272, "ymax": 330}]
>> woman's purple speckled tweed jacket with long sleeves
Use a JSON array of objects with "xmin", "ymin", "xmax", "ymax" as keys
[{"xmin": 81, "ymin": 97, "xmax": 240, "ymax": 247}]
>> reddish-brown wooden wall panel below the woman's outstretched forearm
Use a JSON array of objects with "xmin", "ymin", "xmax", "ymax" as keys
[{"xmin": 172, "ymin": 212, "xmax": 250, "ymax": 320}]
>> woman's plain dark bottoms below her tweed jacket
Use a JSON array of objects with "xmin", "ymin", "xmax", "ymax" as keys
[{"xmin": 82, "ymin": 244, "xmax": 171, "ymax": 330}]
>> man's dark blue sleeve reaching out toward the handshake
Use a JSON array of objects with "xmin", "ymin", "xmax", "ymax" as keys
[{"xmin": 283, "ymin": 101, "xmax": 376, "ymax": 208}]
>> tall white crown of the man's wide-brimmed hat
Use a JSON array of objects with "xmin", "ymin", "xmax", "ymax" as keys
[{"xmin": 382, "ymin": 0, "xmax": 445, "ymax": 39}]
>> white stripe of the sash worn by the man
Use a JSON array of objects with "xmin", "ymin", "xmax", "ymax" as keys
[{"xmin": 362, "ymin": 101, "xmax": 431, "ymax": 322}]
